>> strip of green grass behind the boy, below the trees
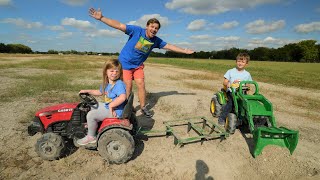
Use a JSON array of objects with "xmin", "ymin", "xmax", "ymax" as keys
[{"xmin": 147, "ymin": 58, "xmax": 320, "ymax": 89}]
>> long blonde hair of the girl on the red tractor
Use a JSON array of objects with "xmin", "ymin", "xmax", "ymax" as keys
[{"xmin": 102, "ymin": 59, "xmax": 123, "ymax": 95}]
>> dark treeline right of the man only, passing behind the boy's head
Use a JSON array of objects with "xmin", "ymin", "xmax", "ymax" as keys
[{"xmin": 151, "ymin": 40, "xmax": 320, "ymax": 63}]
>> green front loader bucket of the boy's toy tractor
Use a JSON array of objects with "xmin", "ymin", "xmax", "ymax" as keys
[{"xmin": 253, "ymin": 127, "xmax": 299, "ymax": 157}]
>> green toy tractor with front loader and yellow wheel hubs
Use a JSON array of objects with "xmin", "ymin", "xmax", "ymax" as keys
[{"xmin": 210, "ymin": 81, "xmax": 299, "ymax": 157}]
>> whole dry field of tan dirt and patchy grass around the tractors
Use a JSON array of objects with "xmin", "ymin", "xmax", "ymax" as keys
[{"xmin": 0, "ymin": 55, "xmax": 320, "ymax": 180}]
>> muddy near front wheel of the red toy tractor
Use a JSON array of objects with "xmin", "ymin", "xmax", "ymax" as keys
[{"xmin": 35, "ymin": 133, "xmax": 65, "ymax": 161}]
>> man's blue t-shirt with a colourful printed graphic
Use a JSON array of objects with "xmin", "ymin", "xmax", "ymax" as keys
[{"xmin": 119, "ymin": 25, "xmax": 167, "ymax": 70}]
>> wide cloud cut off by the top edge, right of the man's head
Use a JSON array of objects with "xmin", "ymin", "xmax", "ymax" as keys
[{"xmin": 165, "ymin": 0, "xmax": 281, "ymax": 15}]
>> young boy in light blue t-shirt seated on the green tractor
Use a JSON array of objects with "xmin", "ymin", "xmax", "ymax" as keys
[{"xmin": 218, "ymin": 53, "xmax": 252, "ymax": 125}]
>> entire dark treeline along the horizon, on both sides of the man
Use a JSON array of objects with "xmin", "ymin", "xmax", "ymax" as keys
[{"xmin": 0, "ymin": 40, "xmax": 320, "ymax": 63}]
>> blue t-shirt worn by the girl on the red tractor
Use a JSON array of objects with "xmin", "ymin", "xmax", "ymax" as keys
[{"xmin": 100, "ymin": 80, "xmax": 126, "ymax": 117}]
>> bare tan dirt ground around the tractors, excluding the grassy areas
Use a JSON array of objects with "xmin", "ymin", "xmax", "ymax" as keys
[{"xmin": 0, "ymin": 59, "xmax": 320, "ymax": 180}]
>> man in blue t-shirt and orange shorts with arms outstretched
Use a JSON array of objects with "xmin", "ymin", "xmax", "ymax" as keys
[{"xmin": 89, "ymin": 8, "xmax": 194, "ymax": 117}]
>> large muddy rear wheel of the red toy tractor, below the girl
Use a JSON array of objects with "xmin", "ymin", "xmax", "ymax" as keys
[{"xmin": 98, "ymin": 128, "xmax": 135, "ymax": 164}]
